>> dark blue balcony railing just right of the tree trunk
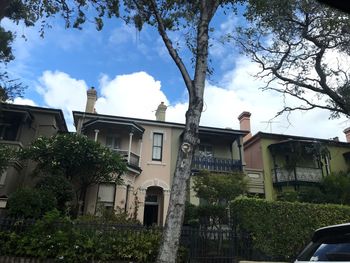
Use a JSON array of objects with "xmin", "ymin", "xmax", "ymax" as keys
[{"xmin": 192, "ymin": 156, "xmax": 242, "ymax": 172}]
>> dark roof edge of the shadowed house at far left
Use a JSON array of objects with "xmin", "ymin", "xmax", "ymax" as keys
[{"xmin": 0, "ymin": 102, "xmax": 68, "ymax": 131}]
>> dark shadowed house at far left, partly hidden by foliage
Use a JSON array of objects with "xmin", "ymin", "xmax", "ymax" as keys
[{"xmin": 0, "ymin": 103, "xmax": 67, "ymax": 214}]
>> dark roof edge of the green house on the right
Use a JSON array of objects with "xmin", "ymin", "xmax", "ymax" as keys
[{"xmin": 244, "ymin": 132, "xmax": 350, "ymax": 147}]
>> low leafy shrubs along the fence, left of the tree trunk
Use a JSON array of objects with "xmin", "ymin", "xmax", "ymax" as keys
[{"xmin": 0, "ymin": 210, "xmax": 161, "ymax": 262}]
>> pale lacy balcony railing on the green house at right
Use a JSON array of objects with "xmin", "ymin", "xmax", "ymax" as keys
[{"xmin": 272, "ymin": 167, "xmax": 323, "ymax": 183}]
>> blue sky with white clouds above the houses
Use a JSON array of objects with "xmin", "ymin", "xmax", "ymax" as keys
[{"xmin": 1, "ymin": 5, "xmax": 350, "ymax": 141}]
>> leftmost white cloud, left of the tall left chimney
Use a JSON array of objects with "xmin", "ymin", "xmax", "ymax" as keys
[{"xmin": 36, "ymin": 71, "xmax": 87, "ymax": 130}]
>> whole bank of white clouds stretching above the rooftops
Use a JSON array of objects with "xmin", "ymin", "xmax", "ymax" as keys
[{"xmin": 30, "ymin": 58, "xmax": 349, "ymax": 141}]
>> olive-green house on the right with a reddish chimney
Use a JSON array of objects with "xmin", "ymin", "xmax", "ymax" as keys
[{"xmin": 239, "ymin": 112, "xmax": 350, "ymax": 200}]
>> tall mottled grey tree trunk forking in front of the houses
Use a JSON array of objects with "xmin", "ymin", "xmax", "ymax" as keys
[{"xmin": 157, "ymin": 0, "xmax": 218, "ymax": 263}]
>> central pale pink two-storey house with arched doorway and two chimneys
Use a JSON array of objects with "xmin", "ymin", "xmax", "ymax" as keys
[{"xmin": 73, "ymin": 88, "xmax": 261, "ymax": 225}]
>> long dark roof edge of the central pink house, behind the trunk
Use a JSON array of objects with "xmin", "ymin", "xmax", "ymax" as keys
[{"xmin": 73, "ymin": 111, "xmax": 249, "ymax": 136}]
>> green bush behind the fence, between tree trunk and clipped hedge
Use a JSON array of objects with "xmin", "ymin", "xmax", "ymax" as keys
[{"xmin": 189, "ymin": 171, "xmax": 247, "ymax": 228}]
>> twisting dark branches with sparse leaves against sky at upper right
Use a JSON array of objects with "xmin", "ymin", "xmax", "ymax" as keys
[{"xmin": 235, "ymin": 0, "xmax": 350, "ymax": 117}]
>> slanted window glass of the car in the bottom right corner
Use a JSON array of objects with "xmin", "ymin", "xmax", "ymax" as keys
[{"xmin": 298, "ymin": 235, "xmax": 350, "ymax": 262}]
